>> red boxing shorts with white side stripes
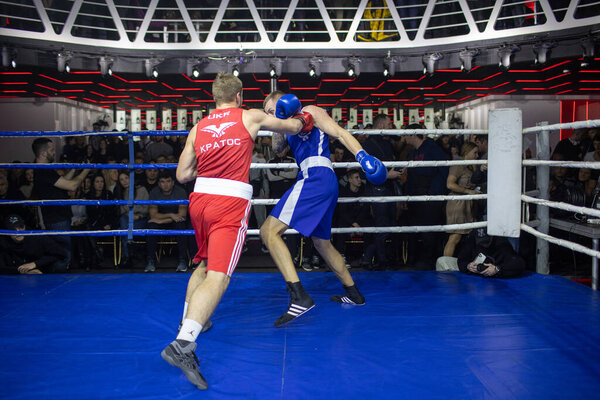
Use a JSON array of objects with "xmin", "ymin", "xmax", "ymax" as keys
[{"xmin": 189, "ymin": 192, "xmax": 252, "ymax": 276}]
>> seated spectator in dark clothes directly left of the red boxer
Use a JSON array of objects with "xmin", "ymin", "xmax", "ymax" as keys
[{"xmin": 144, "ymin": 171, "xmax": 188, "ymax": 272}]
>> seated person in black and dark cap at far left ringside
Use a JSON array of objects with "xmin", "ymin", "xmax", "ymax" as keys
[{"xmin": 0, "ymin": 214, "xmax": 67, "ymax": 274}]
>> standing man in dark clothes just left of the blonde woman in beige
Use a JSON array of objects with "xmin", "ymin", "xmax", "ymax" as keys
[{"xmin": 403, "ymin": 124, "xmax": 448, "ymax": 268}]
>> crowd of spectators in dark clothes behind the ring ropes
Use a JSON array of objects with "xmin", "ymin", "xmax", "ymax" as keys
[{"xmin": 0, "ymin": 111, "xmax": 548, "ymax": 272}]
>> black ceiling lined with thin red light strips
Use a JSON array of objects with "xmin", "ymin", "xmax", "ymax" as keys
[{"xmin": 0, "ymin": 57, "xmax": 600, "ymax": 119}]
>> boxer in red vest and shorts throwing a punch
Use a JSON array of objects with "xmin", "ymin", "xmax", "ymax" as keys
[{"xmin": 161, "ymin": 72, "xmax": 313, "ymax": 389}]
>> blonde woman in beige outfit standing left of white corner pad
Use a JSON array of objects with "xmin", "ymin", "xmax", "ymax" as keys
[{"xmin": 444, "ymin": 142, "xmax": 480, "ymax": 257}]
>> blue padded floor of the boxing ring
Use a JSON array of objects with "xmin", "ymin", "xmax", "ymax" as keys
[{"xmin": 0, "ymin": 271, "xmax": 600, "ymax": 400}]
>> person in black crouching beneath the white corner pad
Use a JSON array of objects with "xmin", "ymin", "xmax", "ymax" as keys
[{"xmin": 436, "ymin": 228, "xmax": 525, "ymax": 278}]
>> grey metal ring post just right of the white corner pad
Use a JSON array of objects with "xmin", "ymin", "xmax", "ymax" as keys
[{"xmin": 535, "ymin": 122, "xmax": 550, "ymax": 274}]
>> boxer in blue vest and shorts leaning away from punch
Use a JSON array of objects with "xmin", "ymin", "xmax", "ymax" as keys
[{"xmin": 260, "ymin": 91, "xmax": 387, "ymax": 326}]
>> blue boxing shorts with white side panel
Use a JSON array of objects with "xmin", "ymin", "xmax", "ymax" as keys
[{"xmin": 271, "ymin": 166, "xmax": 338, "ymax": 240}]
